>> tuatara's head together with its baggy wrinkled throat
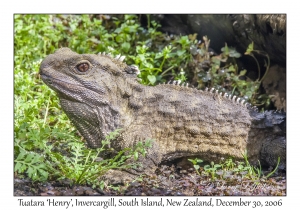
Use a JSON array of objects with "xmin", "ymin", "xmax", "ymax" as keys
[{"xmin": 40, "ymin": 48, "xmax": 140, "ymax": 148}]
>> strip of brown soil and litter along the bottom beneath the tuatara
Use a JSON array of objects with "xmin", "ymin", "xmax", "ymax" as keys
[{"xmin": 14, "ymin": 165, "xmax": 286, "ymax": 196}]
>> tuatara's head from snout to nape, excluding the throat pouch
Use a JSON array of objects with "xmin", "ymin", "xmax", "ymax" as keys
[{"xmin": 40, "ymin": 48, "xmax": 139, "ymax": 106}]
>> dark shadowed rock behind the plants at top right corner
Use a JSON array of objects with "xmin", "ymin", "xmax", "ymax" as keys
[{"xmin": 151, "ymin": 14, "xmax": 286, "ymax": 64}]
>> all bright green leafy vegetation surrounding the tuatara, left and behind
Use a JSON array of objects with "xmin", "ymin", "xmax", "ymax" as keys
[{"xmin": 14, "ymin": 15, "xmax": 269, "ymax": 187}]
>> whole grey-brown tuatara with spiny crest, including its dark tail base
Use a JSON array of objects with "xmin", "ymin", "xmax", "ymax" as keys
[{"xmin": 40, "ymin": 48, "xmax": 286, "ymax": 183}]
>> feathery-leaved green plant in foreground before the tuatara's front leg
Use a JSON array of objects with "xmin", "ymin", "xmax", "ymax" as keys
[{"xmin": 15, "ymin": 130, "xmax": 151, "ymax": 188}]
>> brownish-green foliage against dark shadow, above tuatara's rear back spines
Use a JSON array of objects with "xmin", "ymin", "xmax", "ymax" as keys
[{"xmin": 191, "ymin": 36, "xmax": 270, "ymax": 108}]
